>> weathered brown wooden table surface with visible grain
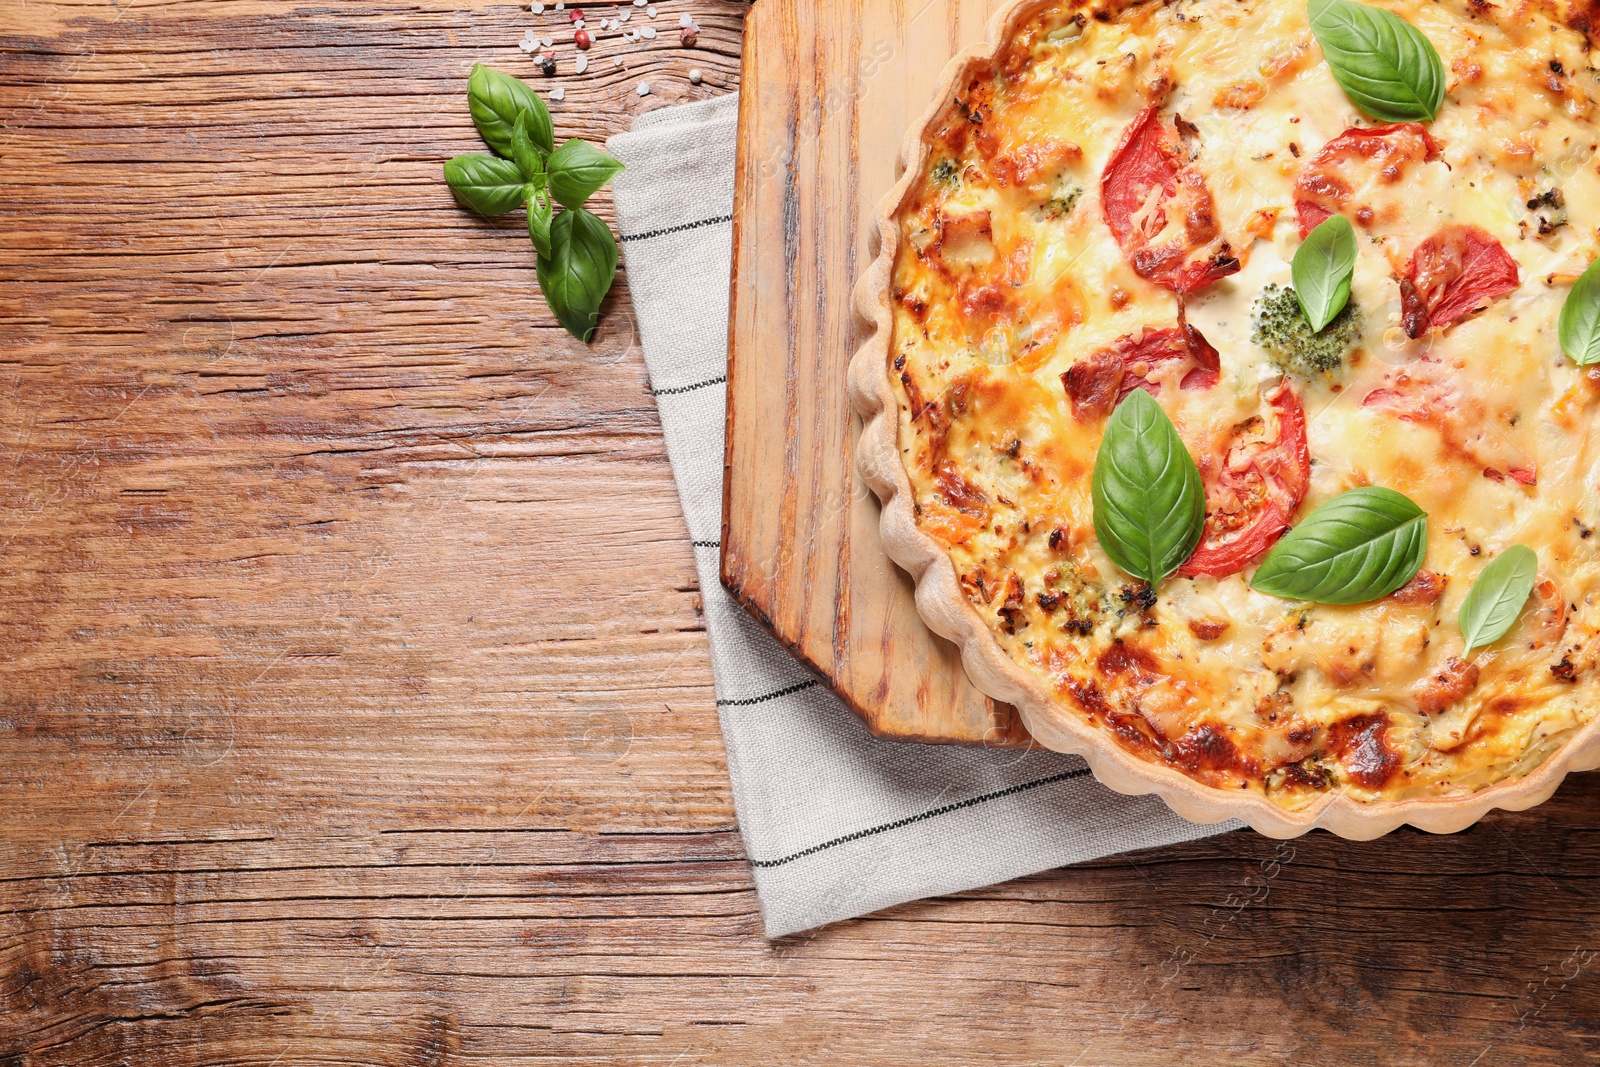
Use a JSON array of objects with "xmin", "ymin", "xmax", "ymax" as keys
[{"xmin": 9, "ymin": 0, "xmax": 1600, "ymax": 1067}]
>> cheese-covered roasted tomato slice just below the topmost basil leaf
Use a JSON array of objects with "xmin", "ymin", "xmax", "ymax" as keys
[{"xmin": 1294, "ymin": 122, "xmax": 1438, "ymax": 237}]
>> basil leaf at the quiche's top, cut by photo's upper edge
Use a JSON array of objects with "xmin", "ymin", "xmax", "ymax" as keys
[{"xmin": 1306, "ymin": 0, "xmax": 1445, "ymax": 122}]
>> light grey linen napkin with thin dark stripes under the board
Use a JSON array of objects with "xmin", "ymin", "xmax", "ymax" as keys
[{"xmin": 606, "ymin": 94, "xmax": 1238, "ymax": 937}]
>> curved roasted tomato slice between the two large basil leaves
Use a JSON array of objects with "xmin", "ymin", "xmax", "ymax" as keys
[{"xmin": 1178, "ymin": 381, "xmax": 1310, "ymax": 577}]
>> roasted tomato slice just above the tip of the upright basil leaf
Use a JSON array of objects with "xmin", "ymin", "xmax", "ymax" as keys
[{"xmin": 1061, "ymin": 323, "xmax": 1222, "ymax": 419}]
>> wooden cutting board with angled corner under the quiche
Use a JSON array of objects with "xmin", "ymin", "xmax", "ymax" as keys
[{"xmin": 722, "ymin": 0, "xmax": 1030, "ymax": 747}]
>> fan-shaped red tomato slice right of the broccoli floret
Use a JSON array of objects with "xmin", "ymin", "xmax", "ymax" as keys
[{"xmin": 1400, "ymin": 222, "xmax": 1522, "ymax": 338}]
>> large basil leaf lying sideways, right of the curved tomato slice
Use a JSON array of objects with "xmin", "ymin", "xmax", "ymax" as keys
[{"xmin": 1250, "ymin": 485, "xmax": 1427, "ymax": 605}]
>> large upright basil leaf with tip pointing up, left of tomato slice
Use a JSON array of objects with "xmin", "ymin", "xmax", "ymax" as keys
[{"xmin": 1090, "ymin": 389, "xmax": 1205, "ymax": 585}]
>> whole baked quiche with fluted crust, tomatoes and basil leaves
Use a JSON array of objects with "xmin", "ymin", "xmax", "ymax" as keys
[{"xmin": 851, "ymin": 0, "xmax": 1600, "ymax": 837}]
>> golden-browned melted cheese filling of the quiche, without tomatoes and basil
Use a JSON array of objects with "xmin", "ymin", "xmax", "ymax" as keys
[{"xmin": 890, "ymin": 0, "xmax": 1600, "ymax": 806}]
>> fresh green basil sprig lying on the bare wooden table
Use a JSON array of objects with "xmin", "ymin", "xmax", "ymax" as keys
[{"xmin": 445, "ymin": 66, "xmax": 622, "ymax": 341}]
